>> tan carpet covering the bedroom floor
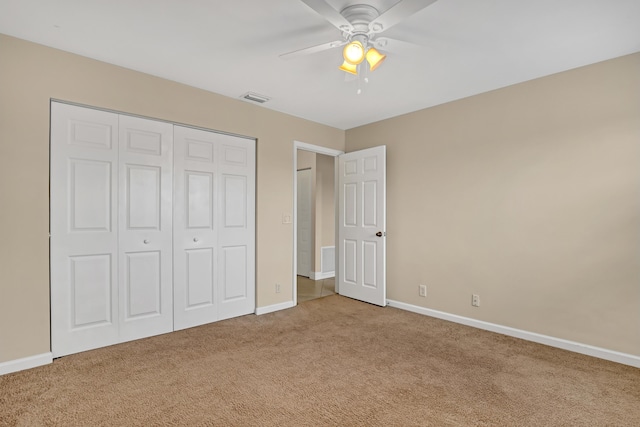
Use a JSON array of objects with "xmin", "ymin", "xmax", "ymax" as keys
[{"xmin": 0, "ymin": 295, "xmax": 640, "ymax": 426}]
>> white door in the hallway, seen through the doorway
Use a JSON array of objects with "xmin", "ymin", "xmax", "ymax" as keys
[{"xmin": 296, "ymin": 169, "xmax": 313, "ymax": 277}]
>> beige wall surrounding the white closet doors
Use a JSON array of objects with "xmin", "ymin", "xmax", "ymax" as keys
[{"xmin": 0, "ymin": 35, "xmax": 344, "ymax": 363}]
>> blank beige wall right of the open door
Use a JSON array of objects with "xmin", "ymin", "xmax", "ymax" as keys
[{"xmin": 347, "ymin": 54, "xmax": 640, "ymax": 355}]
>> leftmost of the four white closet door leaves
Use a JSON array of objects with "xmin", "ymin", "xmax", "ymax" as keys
[{"xmin": 50, "ymin": 103, "xmax": 119, "ymax": 357}]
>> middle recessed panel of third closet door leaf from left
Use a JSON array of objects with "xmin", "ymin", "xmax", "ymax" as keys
[{"xmin": 185, "ymin": 171, "xmax": 215, "ymax": 229}]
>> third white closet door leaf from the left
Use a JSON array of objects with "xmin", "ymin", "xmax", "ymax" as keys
[{"xmin": 173, "ymin": 126, "xmax": 219, "ymax": 330}]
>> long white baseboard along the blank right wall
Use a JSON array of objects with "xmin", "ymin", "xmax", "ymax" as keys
[{"xmin": 387, "ymin": 300, "xmax": 640, "ymax": 368}]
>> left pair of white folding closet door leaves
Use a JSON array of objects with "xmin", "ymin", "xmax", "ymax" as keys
[{"xmin": 51, "ymin": 103, "xmax": 173, "ymax": 357}]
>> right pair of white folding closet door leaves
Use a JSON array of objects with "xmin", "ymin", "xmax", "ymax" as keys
[{"xmin": 173, "ymin": 126, "xmax": 255, "ymax": 330}]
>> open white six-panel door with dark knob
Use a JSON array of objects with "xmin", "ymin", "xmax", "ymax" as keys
[{"xmin": 336, "ymin": 146, "xmax": 387, "ymax": 306}]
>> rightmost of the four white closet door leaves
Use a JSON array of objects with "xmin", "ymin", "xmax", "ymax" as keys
[{"xmin": 218, "ymin": 135, "xmax": 255, "ymax": 319}]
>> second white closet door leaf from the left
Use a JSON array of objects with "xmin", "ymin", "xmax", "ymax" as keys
[{"xmin": 118, "ymin": 115, "xmax": 173, "ymax": 341}]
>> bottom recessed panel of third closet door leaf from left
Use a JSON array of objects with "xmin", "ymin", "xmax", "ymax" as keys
[{"xmin": 186, "ymin": 248, "xmax": 215, "ymax": 310}]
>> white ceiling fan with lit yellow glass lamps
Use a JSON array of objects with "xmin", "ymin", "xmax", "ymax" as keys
[{"xmin": 280, "ymin": 0, "xmax": 436, "ymax": 75}]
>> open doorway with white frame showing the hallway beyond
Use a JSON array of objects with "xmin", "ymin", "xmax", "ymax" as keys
[{"xmin": 292, "ymin": 141, "xmax": 343, "ymax": 305}]
